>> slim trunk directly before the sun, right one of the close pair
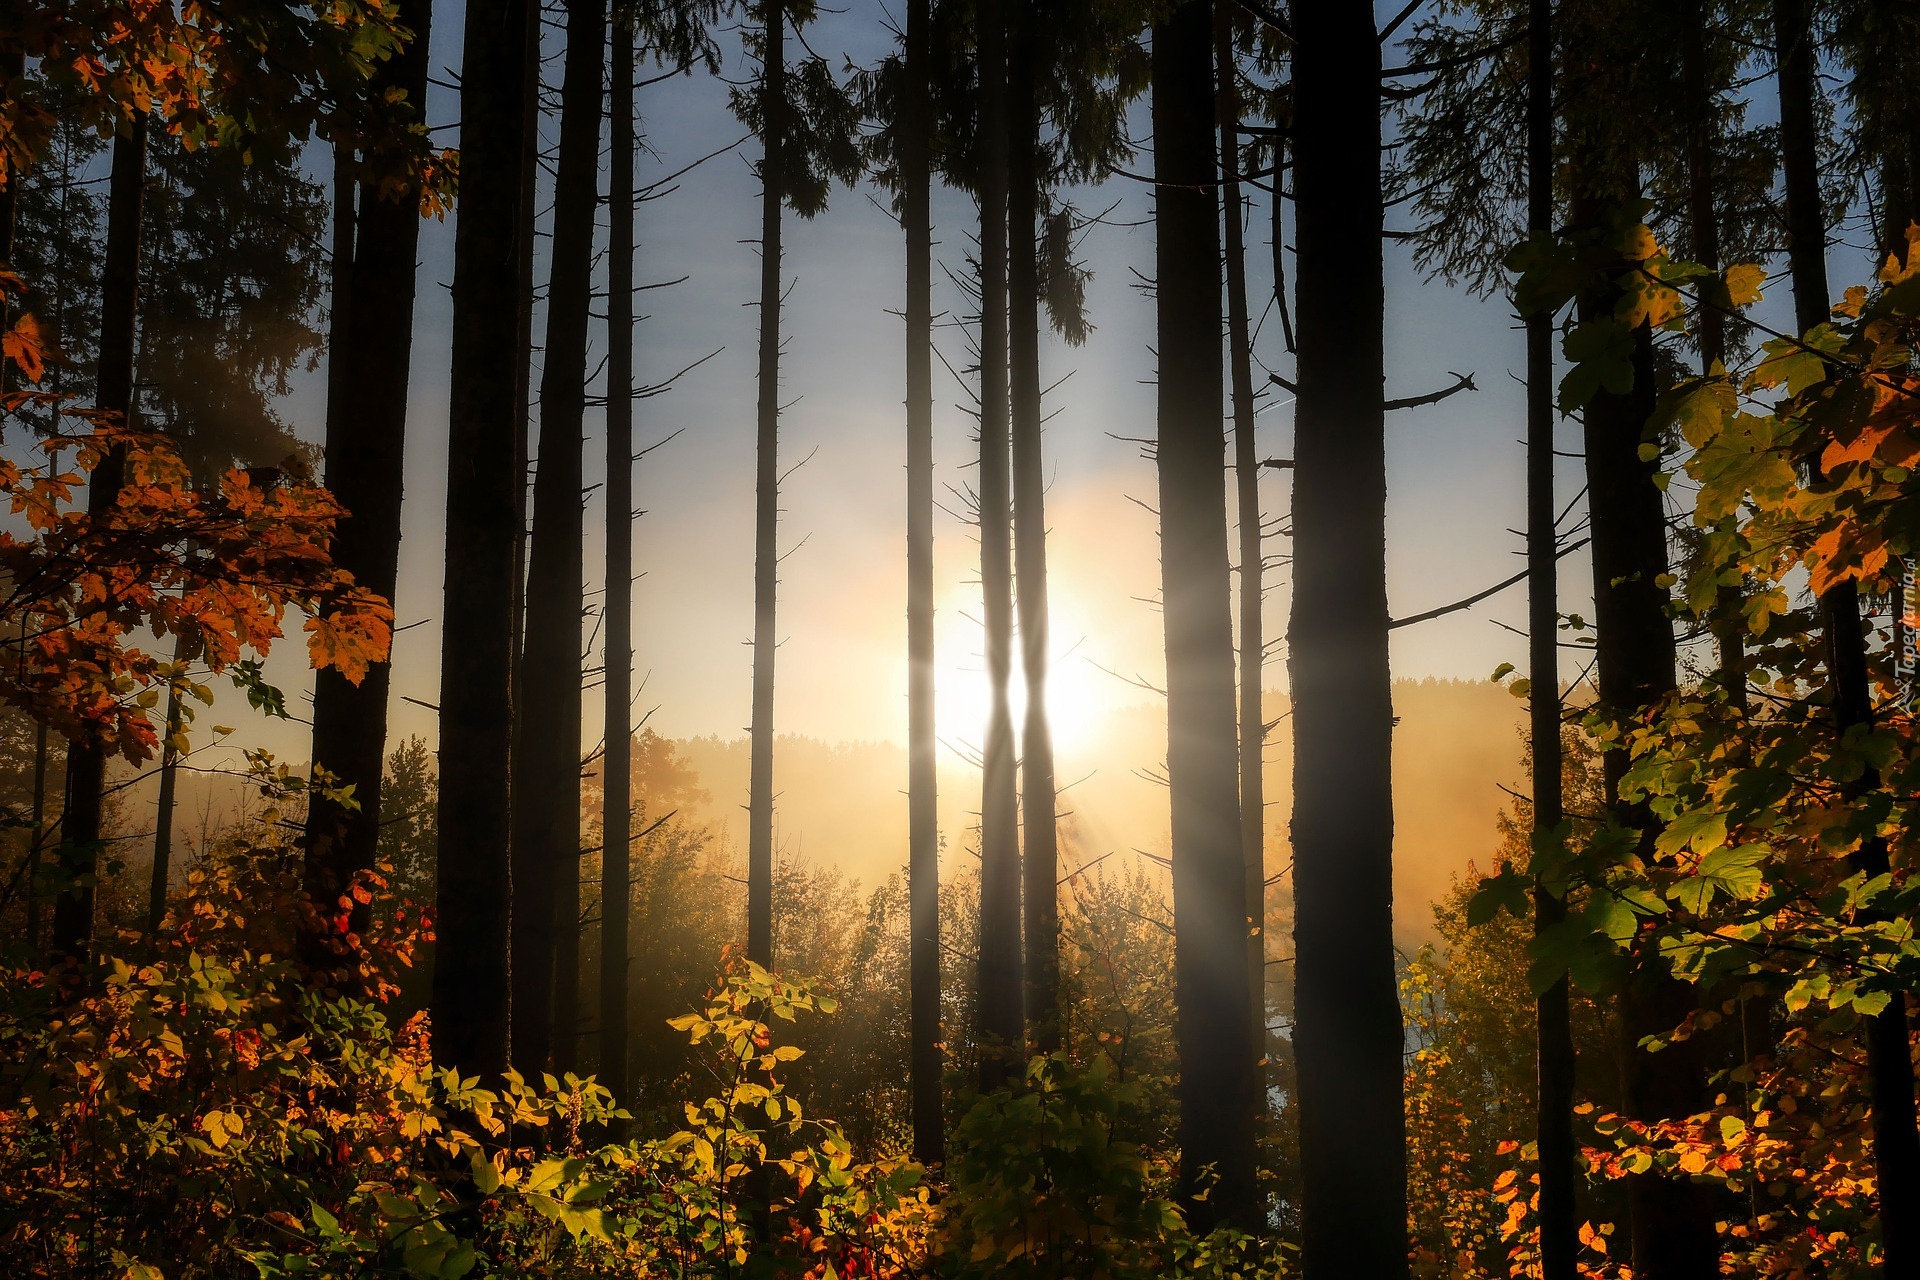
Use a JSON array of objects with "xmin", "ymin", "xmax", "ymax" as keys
[{"xmin": 1006, "ymin": 0, "xmax": 1060, "ymax": 1054}]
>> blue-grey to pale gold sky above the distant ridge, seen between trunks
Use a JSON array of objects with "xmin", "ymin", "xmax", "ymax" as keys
[{"xmin": 275, "ymin": 0, "xmax": 1551, "ymax": 782}]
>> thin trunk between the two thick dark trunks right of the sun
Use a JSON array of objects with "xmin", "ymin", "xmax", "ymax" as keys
[{"xmin": 1213, "ymin": 4, "xmax": 1281, "ymax": 1059}]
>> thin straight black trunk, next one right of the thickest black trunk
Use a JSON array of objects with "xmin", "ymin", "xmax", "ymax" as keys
[{"xmin": 1526, "ymin": 0, "xmax": 1580, "ymax": 1280}]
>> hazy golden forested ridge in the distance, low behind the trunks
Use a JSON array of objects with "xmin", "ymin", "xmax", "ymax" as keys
[{"xmin": 139, "ymin": 679, "xmax": 1526, "ymax": 946}]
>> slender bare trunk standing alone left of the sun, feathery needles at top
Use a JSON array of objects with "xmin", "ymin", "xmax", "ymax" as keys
[{"xmin": 747, "ymin": 0, "xmax": 787, "ymax": 965}]
